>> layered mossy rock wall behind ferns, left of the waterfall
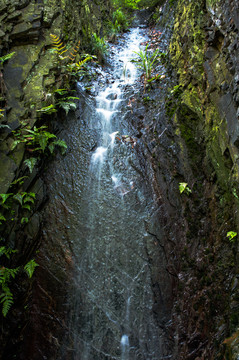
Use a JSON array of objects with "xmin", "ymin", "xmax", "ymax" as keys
[{"xmin": 0, "ymin": 0, "xmax": 111, "ymax": 360}]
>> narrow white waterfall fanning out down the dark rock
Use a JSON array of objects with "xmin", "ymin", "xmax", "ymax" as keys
[{"xmin": 44, "ymin": 19, "xmax": 166, "ymax": 360}]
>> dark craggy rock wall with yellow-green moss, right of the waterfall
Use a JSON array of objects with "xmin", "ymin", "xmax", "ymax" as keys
[{"xmin": 145, "ymin": 0, "xmax": 239, "ymax": 360}]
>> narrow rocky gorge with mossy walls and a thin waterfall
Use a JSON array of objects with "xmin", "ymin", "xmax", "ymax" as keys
[{"xmin": 0, "ymin": 0, "xmax": 239, "ymax": 360}]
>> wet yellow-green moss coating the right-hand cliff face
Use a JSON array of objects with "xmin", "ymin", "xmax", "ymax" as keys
[{"xmin": 168, "ymin": 0, "xmax": 239, "ymax": 359}]
